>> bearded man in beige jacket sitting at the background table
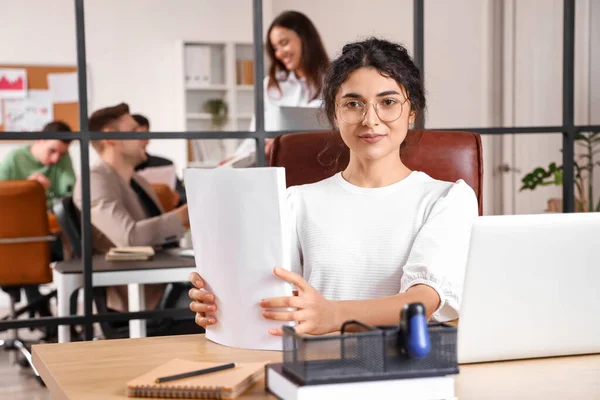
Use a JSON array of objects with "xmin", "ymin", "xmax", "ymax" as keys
[{"xmin": 73, "ymin": 103, "xmax": 189, "ymax": 311}]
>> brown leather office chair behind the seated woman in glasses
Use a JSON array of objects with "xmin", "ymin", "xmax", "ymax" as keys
[{"xmin": 270, "ymin": 130, "xmax": 483, "ymax": 215}]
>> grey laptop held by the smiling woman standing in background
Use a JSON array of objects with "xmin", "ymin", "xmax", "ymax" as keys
[{"xmin": 265, "ymin": 106, "xmax": 331, "ymax": 132}]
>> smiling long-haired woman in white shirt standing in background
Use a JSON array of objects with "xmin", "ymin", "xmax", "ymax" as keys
[{"xmin": 236, "ymin": 11, "xmax": 330, "ymax": 156}]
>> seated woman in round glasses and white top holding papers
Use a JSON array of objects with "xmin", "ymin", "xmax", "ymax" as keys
[{"xmin": 190, "ymin": 39, "xmax": 478, "ymax": 335}]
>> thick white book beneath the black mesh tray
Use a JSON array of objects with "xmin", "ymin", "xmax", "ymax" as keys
[{"xmin": 265, "ymin": 363, "xmax": 455, "ymax": 400}]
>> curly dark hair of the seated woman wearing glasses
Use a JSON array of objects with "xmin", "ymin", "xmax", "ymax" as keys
[{"xmin": 323, "ymin": 37, "xmax": 426, "ymax": 129}]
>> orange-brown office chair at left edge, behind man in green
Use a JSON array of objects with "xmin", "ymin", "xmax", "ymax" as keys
[{"xmin": 0, "ymin": 181, "xmax": 56, "ymax": 379}]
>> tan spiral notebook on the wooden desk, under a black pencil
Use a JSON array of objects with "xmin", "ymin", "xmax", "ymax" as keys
[{"xmin": 127, "ymin": 359, "xmax": 266, "ymax": 399}]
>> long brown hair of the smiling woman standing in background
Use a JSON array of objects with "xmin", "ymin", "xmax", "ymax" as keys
[{"xmin": 265, "ymin": 11, "xmax": 329, "ymax": 100}]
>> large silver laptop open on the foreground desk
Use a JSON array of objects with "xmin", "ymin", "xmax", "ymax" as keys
[{"xmin": 458, "ymin": 213, "xmax": 600, "ymax": 363}]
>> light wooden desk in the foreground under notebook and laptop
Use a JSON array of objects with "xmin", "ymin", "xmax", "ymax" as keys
[{"xmin": 33, "ymin": 335, "xmax": 600, "ymax": 400}]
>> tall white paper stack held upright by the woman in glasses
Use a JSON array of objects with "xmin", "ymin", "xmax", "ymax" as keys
[{"xmin": 183, "ymin": 168, "xmax": 292, "ymax": 350}]
